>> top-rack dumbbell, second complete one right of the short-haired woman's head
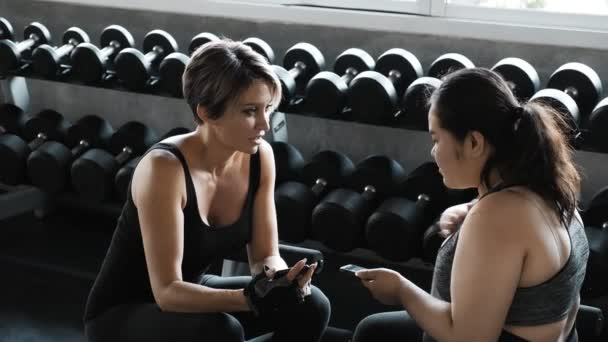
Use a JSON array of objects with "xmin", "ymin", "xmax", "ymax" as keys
[{"xmin": 304, "ymin": 48, "xmax": 376, "ymax": 118}]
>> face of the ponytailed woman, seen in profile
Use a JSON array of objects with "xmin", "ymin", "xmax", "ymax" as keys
[{"xmin": 429, "ymin": 105, "xmax": 485, "ymax": 189}]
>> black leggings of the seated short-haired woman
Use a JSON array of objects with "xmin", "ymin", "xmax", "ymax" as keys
[{"xmin": 85, "ymin": 275, "xmax": 331, "ymax": 342}]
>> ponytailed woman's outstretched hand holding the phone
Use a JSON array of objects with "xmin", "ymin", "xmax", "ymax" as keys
[{"xmin": 355, "ymin": 268, "xmax": 405, "ymax": 305}]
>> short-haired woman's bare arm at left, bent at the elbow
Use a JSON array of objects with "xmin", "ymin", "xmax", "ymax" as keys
[{"xmin": 132, "ymin": 150, "xmax": 249, "ymax": 312}]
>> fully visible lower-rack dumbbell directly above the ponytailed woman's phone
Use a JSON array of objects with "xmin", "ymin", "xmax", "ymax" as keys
[{"xmin": 365, "ymin": 162, "xmax": 447, "ymax": 261}]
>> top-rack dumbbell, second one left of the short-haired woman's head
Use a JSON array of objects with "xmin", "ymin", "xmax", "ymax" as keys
[{"xmin": 114, "ymin": 30, "xmax": 178, "ymax": 90}]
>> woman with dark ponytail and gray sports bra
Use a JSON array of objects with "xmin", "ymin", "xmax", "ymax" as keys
[{"xmin": 354, "ymin": 68, "xmax": 589, "ymax": 342}]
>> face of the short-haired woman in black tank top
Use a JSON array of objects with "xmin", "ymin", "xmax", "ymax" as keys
[{"xmin": 205, "ymin": 80, "xmax": 272, "ymax": 154}]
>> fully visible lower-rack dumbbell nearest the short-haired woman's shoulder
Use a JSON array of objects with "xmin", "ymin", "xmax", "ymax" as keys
[{"xmin": 70, "ymin": 121, "xmax": 158, "ymax": 202}]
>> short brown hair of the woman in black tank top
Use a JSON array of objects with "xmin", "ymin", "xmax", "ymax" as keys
[{"xmin": 183, "ymin": 39, "xmax": 281, "ymax": 124}]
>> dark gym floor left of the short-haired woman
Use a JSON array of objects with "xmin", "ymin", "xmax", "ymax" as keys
[{"xmin": 0, "ymin": 213, "xmax": 112, "ymax": 342}]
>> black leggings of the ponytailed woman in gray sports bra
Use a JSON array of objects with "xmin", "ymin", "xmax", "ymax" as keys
[{"xmin": 352, "ymin": 311, "xmax": 578, "ymax": 342}]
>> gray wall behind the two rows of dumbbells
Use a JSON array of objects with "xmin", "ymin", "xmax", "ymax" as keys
[{"xmin": 0, "ymin": 0, "xmax": 608, "ymax": 206}]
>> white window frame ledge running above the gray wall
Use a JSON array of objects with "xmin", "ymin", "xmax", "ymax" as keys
[{"xmin": 41, "ymin": 0, "xmax": 608, "ymax": 50}]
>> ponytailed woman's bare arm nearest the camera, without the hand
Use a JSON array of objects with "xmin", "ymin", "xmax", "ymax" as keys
[{"xmin": 400, "ymin": 194, "xmax": 526, "ymax": 341}]
